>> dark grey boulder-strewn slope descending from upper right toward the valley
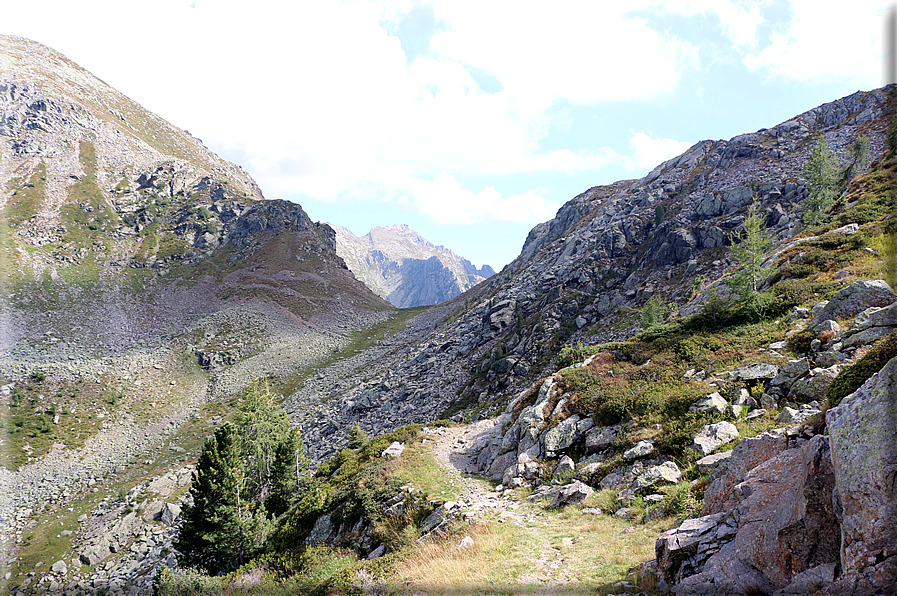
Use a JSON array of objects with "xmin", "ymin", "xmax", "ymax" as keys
[{"xmin": 287, "ymin": 84, "xmax": 890, "ymax": 456}]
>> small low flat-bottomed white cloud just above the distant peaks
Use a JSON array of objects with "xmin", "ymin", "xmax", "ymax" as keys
[{"xmin": 411, "ymin": 172, "xmax": 558, "ymax": 224}]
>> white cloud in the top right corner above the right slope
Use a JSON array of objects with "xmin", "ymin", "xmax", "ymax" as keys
[{"xmin": 743, "ymin": 0, "xmax": 880, "ymax": 88}]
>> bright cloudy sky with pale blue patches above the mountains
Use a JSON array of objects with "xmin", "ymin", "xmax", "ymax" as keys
[{"xmin": 0, "ymin": 0, "xmax": 893, "ymax": 270}]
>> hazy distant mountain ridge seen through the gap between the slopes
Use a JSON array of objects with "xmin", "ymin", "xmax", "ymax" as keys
[{"xmin": 331, "ymin": 224, "xmax": 495, "ymax": 308}]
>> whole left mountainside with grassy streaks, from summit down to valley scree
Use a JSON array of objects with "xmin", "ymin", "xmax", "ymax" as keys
[{"xmin": 0, "ymin": 36, "xmax": 395, "ymax": 587}]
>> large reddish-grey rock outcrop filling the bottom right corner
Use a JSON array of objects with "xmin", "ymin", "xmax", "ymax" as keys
[{"xmin": 657, "ymin": 358, "xmax": 897, "ymax": 596}]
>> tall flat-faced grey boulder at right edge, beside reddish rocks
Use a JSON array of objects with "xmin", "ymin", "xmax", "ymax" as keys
[{"xmin": 826, "ymin": 358, "xmax": 897, "ymax": 585}]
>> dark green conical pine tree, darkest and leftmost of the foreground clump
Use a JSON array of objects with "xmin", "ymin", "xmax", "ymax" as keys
[{"xmin": 176, "ymin": 424, "xmax": 264, "ymax": 575}]
